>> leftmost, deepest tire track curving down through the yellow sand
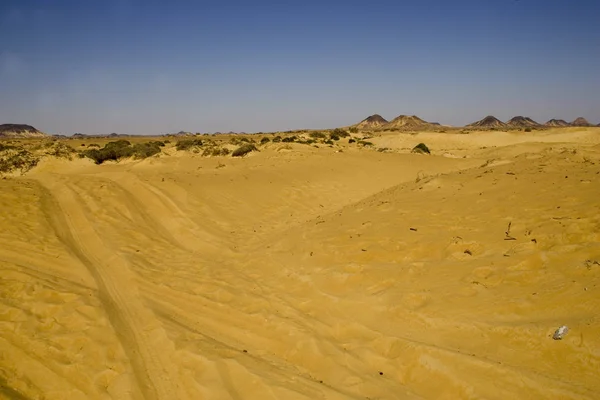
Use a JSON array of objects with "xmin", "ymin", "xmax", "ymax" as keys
[{"xmin": 39, "ymin": 175, "xmax": 189, "ymax": 400}]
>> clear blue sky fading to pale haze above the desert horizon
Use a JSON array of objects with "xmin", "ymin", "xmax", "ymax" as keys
[{"xmin": 0, "ymin": 0, "xmax": 600, "ymax": 134}]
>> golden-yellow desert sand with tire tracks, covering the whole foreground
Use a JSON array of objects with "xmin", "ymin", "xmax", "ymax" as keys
[{"xmin": 0, "ymin": 128, "xmax": 600, "ymax": 400}]
